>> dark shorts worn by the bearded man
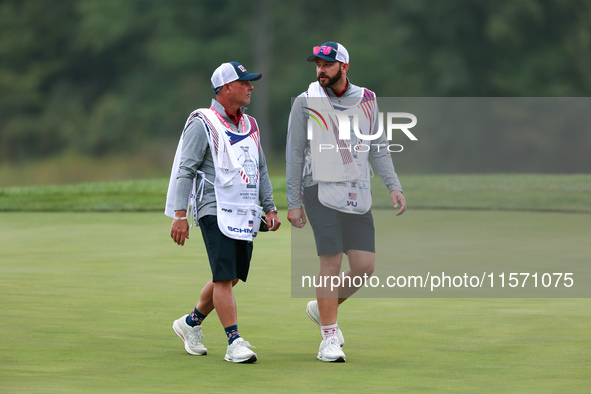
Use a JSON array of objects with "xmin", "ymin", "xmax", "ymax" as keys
[{"xmin": 304, "ymin": 185, "xmax": 376, "ymax": 256}]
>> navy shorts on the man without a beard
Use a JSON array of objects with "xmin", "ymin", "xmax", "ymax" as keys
[{"xmin": 199, "ymin": 215, "xmax": 253, "ymax": 282}]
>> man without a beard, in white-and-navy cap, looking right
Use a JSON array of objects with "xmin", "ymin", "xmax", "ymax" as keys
[{"xmin": 165, "ymin": 62, "xmax": 281, "ymax": 363}]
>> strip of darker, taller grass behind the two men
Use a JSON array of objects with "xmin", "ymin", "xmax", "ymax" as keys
[{"xmin": 0, "ymin": 174, "xmax": 591, "ymax": 213}]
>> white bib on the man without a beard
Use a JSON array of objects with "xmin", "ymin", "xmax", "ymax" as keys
[{"xmin": 200, "ymin": 108, "xmax": 263, "ymax": 241}]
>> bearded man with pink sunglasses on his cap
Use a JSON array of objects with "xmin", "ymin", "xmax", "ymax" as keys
[{"xmin": 286, "ymin": 41, "xmax": 406, "ymax": 362}]
